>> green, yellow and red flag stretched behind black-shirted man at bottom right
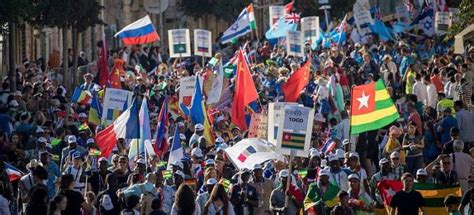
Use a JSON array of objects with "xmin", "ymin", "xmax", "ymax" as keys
[{"xmin": 413, "ymin": 183, "xmax": 462, "ymax": 214}]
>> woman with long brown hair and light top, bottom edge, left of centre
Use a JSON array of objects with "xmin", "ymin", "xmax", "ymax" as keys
[{"xmin": 203, "ymin": 184, "xmax": 235, "ymax": 215}]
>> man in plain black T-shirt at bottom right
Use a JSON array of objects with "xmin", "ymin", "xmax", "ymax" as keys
[{"xmin": 390, "ymin": 173, "xmax": 425, "ymax": 215}]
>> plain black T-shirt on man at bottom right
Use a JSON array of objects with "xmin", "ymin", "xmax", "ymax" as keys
[{"xmin": 390, "ymin": 190, "xmax": 425, "ymax": 215}]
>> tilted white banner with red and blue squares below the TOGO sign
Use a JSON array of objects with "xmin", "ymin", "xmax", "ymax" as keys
[{"xmin": 225, "ymin": 138, "xmax": 286, "ymax": 170}]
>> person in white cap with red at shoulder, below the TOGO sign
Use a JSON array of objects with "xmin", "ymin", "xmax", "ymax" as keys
[{"xmin": 270, "ymin": 169, "xmax": 304, "ymax": 215}]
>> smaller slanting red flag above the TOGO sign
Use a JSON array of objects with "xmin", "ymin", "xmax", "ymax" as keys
[{"xmin": 281, "ymin": 57, "xmax": 311, "ymax": 102}]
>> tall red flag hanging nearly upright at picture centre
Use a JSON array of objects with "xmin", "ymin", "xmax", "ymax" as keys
[{"xmin": 232, "ymin": 50, "xmax": 258, "ymax": 130}]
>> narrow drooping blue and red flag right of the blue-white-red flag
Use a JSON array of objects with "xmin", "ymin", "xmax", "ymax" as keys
[{"xmin": 155, "ymin": 96, "xmax": 168, "ymax": 157}]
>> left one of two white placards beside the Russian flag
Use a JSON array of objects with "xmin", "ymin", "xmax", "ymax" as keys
[{"xmin": 168, "ymin": 29, "xmax": 191, "ymax": 58}]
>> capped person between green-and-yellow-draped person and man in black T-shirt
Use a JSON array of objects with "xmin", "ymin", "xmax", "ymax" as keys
[{"xmin": 347, "ymin": 173, "xmax": 375, "ymax": 214}]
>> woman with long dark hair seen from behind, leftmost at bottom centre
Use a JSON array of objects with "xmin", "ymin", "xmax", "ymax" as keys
[{"xmin": 171, "ymin": 184, "xmax": 201, "ymax": 215}]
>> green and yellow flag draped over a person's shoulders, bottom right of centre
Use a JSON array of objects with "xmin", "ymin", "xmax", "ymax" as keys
[{"xmin": 303, "ymin": 183, "xmax": 339, "ymax": 211}]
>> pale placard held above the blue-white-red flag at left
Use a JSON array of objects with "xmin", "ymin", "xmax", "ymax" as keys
[{"xmin": 101, "ymin": 88, "xmax": 133, "ymax": 125}]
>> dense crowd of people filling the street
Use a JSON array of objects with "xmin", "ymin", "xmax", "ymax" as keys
[{"xmin": 0, "ymin": 17, "xmax": 474, "ymax": 215}]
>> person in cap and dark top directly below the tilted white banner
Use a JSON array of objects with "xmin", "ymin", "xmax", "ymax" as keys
[{"xmin": 230, "ymin": 170, "xmax": 258, "ymax": 215}]
